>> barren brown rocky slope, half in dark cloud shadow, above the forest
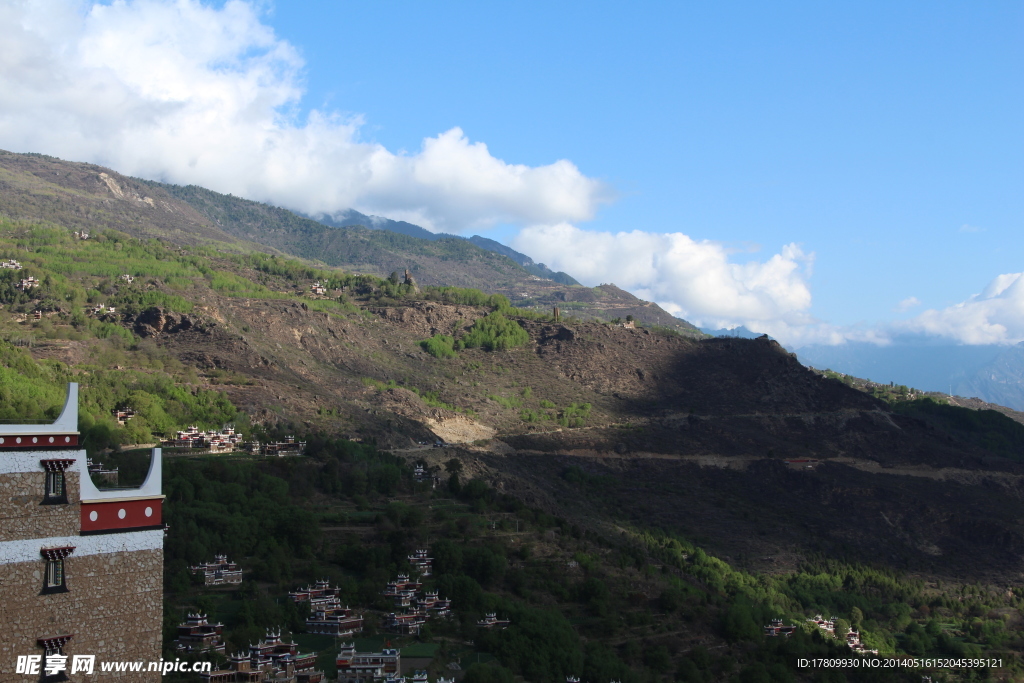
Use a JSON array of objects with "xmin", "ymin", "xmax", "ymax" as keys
[{"xmin": 37, "ymin": 282, "xmax": 1024, "ymax": 582}]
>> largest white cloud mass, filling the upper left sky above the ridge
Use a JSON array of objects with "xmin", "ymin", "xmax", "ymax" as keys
[{"xmin": 0, "ymin": 0, "xmax": 607, "ymax": 231}]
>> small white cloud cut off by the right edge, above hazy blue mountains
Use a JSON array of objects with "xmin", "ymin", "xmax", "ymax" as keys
[{"xmin": 894, "ymin": 272, "xmax": 1024, "ymax": 344}]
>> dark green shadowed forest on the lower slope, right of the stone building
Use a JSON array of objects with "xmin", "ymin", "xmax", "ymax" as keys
[{"xmin": 153, "ymin": 444, "xmax": 1024, "ymax": 682}]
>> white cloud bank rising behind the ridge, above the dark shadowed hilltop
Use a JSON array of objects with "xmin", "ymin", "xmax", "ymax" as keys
[{"xmin": 512, "ymin": 223, "xmax": 814, "ymax": 332}]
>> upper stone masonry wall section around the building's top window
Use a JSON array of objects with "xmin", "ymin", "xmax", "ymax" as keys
[{"xmin": 0, "ymin": 470, "xmax": 81, "ymax": 542}]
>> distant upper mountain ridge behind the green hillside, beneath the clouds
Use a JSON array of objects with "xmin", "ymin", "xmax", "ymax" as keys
[{"xmin": 0, "ymin": 152, "xmax": 699, "ymax": 334}]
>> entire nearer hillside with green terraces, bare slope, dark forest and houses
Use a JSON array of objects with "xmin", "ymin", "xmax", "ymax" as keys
[{"xmin": 6, "ymin": 157, "xmax": 1024, "ymax": 683}]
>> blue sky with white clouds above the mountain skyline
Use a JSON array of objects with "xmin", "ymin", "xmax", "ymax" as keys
[{"xmin": 0, "ymin": 0, "xmax": 1024, "ymax": 343}]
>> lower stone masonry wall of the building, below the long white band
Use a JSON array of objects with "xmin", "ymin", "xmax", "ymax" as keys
[{"xmin": 0, "ymin": 548, "xmax": 164, "ymax": 683}]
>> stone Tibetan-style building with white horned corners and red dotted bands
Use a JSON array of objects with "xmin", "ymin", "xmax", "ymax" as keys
[{"xmin": 0, "ymin": 384, "xmax": 164, "ymax": 682}]
